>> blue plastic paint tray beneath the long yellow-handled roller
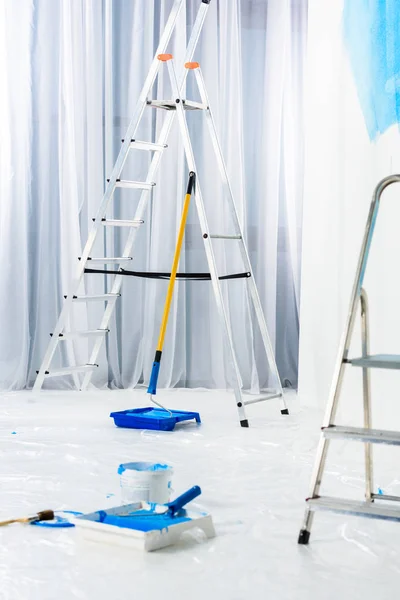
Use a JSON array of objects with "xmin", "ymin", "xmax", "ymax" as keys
[{"xmin": 110, "ymin": 407, "xmax": 201, "ymax": 431}]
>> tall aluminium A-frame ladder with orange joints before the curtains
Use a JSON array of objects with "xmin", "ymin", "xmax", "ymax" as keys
[{"xmin": 34, "ymin": 0, "xmax": 288, "ymax": 427}]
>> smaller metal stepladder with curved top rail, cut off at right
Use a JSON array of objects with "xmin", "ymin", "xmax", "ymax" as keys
[{"xmin": 298, "ymin": 175, "xmax": 400, "ymax": 544}]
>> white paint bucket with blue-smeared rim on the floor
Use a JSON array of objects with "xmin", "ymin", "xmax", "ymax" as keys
[{"xmin": 118, "ymin": 462, "xmax": 173, "ymax": 504}]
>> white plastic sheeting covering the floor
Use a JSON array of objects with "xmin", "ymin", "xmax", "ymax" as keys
[{"xmin": 0, "ymin": 390, "xmax": 400, "ymax": 600}]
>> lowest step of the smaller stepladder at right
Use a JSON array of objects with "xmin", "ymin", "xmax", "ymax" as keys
[{"xmin": 307, "ymin": 496, "xmax": 400, "ymax": 521}]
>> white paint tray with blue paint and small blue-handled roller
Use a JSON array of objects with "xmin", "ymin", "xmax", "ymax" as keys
[{"xmin": 74, "ymin": 486, "xmax": 215, "ymax": 552}]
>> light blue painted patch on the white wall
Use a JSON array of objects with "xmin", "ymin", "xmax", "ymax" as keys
[{"xmin": 343, "ymin": 0, "xmax": 400, "ymax": 141}]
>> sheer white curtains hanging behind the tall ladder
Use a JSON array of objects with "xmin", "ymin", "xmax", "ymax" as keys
[{"xmin": 0, "ymin": 0, "xmax": 307, "ymax": 389}]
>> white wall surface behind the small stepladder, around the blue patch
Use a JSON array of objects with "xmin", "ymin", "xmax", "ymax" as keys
[{"xmin": 299, "ymin": 0, "xmax": 400, "ymax": 418}]
